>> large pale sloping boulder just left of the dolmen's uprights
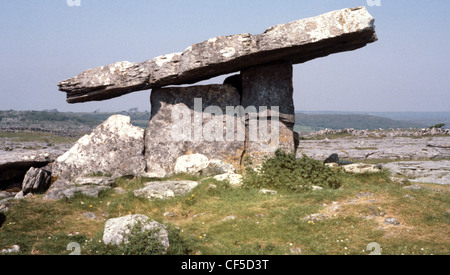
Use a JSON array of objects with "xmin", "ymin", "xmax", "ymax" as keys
[{"xmin": 53, "ymin": 115, "xmax": 145, "ymax": 181}]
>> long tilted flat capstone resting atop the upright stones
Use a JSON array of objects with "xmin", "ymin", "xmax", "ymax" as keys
[{"xmin": 58, "ymin": 7, "xmax": 377, "ymax": 103}]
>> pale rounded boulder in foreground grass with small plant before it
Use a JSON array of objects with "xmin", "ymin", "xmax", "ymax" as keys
[{"xmin": 103, "ymin": 215, "xmax": 170, "ymax": 252}]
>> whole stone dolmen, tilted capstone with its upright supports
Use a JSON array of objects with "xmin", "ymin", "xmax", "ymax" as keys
[{"xmin": 58, "ymin": 7, "xmax": 377, "ymax": 178}]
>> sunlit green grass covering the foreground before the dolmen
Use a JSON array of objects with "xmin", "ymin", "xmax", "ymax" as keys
[{"xmin": 0, "ymin": 172, "xmax": 450, "ymax": 255}]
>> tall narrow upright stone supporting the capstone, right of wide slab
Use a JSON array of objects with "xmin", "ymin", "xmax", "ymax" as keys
[{"xmin": 242, "ymin": 62, "xmax": 296, "ymax": 164}]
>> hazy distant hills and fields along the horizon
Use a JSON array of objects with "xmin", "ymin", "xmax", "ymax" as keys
[{"xmin": 0, "ymin": 110, "xmax": 450, "ymax": 133}]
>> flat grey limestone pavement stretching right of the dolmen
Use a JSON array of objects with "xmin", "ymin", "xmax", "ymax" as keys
[{"xmin": 298, "ymin": 131, "xmax": 450, "ymax": 184}]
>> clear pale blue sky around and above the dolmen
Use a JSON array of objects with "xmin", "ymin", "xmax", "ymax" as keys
[{"xmin": 0, "ymin": 0, "xmax": 450, "ymax": 112}]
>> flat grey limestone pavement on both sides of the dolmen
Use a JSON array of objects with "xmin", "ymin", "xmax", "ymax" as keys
[{"xmin": 0, "ymin": 130, "xmax": 450, "ymax": 195}]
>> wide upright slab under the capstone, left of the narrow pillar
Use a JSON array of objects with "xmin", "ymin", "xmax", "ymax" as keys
[{"xmin": 145, "ymin": 85, "xmax": 245, "ymax": 175}]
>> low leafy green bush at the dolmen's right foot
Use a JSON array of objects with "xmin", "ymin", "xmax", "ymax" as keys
[{"xmin": 243, "ymin": 150, "xmax": 341, "ymax": 192}]
